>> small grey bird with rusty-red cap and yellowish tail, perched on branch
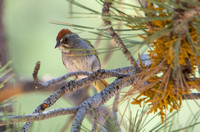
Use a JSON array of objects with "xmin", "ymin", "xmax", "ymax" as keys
[{"xmin": 55, "ymin": 29, "xmax": 109, "ymax": 92}]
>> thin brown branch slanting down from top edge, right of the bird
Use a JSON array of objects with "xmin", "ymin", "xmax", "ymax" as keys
[{"xmin": 102, "ymin": 2, "xmax": 139, "ymax": 71}]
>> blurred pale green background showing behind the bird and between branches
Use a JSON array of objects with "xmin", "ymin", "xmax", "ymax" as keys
[{"xmin": 3, "ymin": 0, "xmax": 200, "ymax": 132}]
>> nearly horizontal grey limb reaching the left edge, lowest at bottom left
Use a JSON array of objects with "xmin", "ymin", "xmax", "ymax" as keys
[{"xmin": 0, "ymin": 107, "xmax": 78, "ymax": 126}]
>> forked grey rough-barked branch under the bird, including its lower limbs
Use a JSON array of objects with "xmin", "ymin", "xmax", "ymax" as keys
[{"xmin": 0, "ymin": 60, "xmax": 200, "ymax": 131}]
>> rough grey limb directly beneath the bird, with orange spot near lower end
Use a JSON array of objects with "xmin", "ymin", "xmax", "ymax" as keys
[{"xmin": 23, "ymin": 64, "xmax": 132, "ymax": 132}]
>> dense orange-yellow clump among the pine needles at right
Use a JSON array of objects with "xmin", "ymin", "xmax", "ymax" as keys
[{"xmin": 129, "ymin": 2, "xmax": 200, "ymax": 123}]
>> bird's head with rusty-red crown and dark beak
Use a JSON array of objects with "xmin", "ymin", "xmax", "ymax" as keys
[{"xmin": 55, "ymin": 29, "xmax": 79, "ymax": 49}]
